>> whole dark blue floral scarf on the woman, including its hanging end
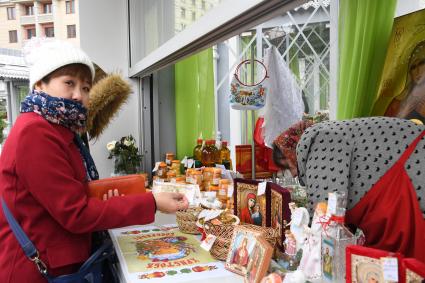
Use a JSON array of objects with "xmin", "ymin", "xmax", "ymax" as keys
[{"xmin": 21, "ymin": 90, "xmax": 99, "ymax": 180}]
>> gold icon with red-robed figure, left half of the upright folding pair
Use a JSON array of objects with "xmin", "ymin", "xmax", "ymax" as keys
[{"xmin": 234, "ymin": 179, "xmax": 267, "ymax": 227}]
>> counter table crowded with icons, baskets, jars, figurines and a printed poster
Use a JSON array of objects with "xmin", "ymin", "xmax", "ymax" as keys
[{"xmin": 109, "ymin": 150, "xmax": 425, "ymax": 283}]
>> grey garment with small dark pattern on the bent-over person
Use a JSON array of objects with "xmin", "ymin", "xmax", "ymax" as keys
[{"xmin": 297, "ymin": 117, "xmax": 425, "ymax": 217}]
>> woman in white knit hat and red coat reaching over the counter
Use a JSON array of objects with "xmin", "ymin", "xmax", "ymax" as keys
[{"xmin": 0, "ymin": 40, "xmax": 188, "ymax": 283}]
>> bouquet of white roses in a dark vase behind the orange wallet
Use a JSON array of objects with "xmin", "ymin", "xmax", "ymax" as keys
[{"xmin": 106, "ymin": 135, "xmax": 143, "ymax": 175}]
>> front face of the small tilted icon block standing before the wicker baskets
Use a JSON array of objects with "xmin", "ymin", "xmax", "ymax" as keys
[{"xmin": 226, "ymin": 226, "xmax": 262, "ymax": 275}]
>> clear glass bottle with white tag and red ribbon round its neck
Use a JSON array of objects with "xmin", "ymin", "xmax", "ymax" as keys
[{"xmin": 322, "ymin": 192, "xmax": 356, "ymax": 283}]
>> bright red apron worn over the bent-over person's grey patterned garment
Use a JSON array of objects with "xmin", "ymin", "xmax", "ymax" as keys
[{"xmin": 346, "ymin": 131, "xmax": 425, "ymax": 262}]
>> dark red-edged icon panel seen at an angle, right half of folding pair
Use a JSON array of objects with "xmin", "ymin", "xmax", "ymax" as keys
[{"xmin": 266, "ymin": 182, "xmax": 291, "ymax": 251}]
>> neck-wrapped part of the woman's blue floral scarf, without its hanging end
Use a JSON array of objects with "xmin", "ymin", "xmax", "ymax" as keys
[{"xmin": 21, "ymin": 90, "xmax": 87, "ymax": 133}]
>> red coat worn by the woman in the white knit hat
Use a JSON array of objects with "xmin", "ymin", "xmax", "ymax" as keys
[{"xmin": 0, "ymin": 113, "xmax": 155, "ymax": 283}]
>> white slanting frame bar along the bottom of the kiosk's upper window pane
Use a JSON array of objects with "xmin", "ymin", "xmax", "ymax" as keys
[{"xmin": 127, "ymin": 0, "xmax": 307, "ymax": 77}]
